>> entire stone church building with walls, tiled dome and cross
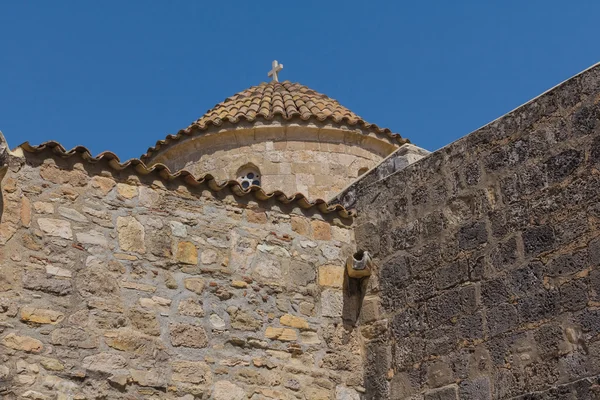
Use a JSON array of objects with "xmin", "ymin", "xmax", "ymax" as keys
[{"xmin": 0, "ymin": 61, "xmax": 600, "ymax": 400}]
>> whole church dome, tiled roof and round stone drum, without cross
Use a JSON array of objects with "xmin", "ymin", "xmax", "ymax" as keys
[{"xmin": 141, "ymin": 81, "xmax": 408, "ymax": 199}]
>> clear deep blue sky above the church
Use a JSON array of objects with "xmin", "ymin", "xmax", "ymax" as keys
[{"xmin": 0, "ymin": 0, "xmax": 600, "ymax": 159}]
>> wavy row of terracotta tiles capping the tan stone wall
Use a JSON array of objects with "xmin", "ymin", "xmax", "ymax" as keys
[{"xmin": 19, "ymin": 142, "xmax": 354, "ymax": 218}]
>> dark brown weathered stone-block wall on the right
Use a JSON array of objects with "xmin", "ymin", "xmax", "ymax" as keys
[{"xmin": 346, "ymin": 66, "xmax": 600, "ymax": 400}]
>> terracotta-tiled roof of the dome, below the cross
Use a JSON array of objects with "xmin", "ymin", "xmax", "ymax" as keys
[{"xmin": 141, "ymin": 81, "xmax": 408, "ymax": 160}]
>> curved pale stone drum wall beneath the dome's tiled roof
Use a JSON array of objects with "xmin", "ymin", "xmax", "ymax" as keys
[{"xmin": 150, "ymin": 122, "xmax": 398, "ymax": 200}]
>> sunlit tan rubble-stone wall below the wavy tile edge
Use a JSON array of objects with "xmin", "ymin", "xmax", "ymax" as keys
[{"xmin": 0, "ymin": 149, "xmax": 363, "ymax": 400}]
